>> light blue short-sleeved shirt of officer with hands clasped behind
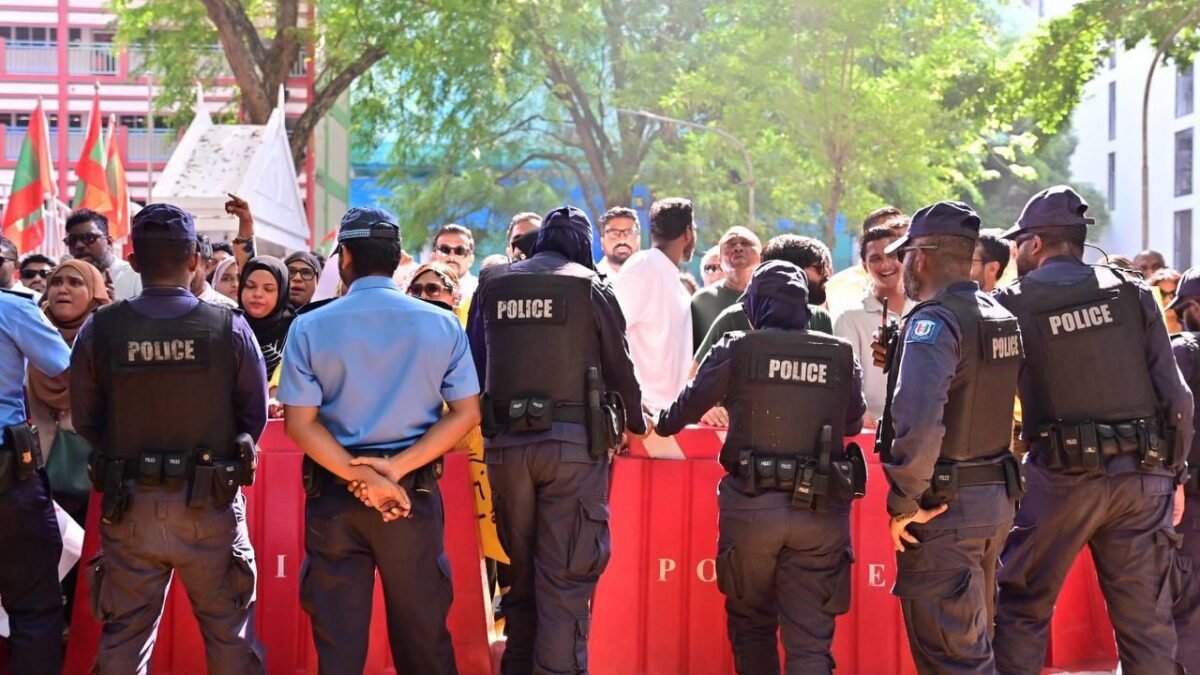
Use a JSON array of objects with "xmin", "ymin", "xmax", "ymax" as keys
[{"xmin": 278, "ymin": 276, "xmax": 479, "ymax": 448}]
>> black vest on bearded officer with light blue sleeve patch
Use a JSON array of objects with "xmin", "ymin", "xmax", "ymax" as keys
[{"xmin": 895, "ymin": 285, "xmax": 1022, "ymax": 461}]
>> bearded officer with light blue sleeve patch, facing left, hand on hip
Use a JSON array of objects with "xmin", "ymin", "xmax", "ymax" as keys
[{"xmin": 880, "ymin": 202, "xmax": 1021, "ymax": 673}]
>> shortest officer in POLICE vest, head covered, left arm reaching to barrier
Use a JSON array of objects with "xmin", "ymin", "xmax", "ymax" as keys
[{"xmin": 655, "ymin": 261, "xmax": 866, "ymax": 674}]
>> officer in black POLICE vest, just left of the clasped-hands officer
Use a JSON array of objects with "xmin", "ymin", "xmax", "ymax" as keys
[{"xmin": 71, "ymin": 204, "xmax": 266, "ymax": 675}]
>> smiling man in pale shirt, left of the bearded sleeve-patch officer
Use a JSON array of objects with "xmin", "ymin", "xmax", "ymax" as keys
[{"xmin": 833, "ymin": 225, "xmax": 914, "ymax": 425}]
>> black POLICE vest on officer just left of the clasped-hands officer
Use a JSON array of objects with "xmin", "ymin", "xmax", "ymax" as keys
[{"xmin": 92, "ymin": 301, "xmax": 236, "ymax": 460}]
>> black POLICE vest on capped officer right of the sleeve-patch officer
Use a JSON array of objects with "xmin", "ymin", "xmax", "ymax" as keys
[{"xmin": 996, "ymin": 267, "xmax": 1158, "ymax": 429}]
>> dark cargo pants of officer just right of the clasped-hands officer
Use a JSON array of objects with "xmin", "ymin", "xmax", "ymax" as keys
[{"xmin": 486, "ymin": 441, "xmax": 611, "ymax": 675}]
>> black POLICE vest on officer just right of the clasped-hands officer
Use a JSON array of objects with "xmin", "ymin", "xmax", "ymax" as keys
[{"xmin": 476, "ymin": 263, "xmax": 604, "ymax": 405}]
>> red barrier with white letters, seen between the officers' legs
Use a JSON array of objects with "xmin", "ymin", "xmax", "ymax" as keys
[{"xmin": 16, "ymin": 423, "xmax": 1116, "ymax": 675}]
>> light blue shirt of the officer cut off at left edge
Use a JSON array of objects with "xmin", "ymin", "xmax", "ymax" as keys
[{"xmin": 0, "ymin": 292, "xmax": 71, "ymax": 426}]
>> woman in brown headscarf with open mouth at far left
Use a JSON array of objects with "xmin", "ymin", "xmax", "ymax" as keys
[{"xmin": 26, "ymin": 259, "xmax": 110, "ymax": 502}]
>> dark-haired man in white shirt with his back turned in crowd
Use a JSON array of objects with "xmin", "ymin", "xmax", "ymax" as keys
[{"xmin": 612, "ymin": 198, "xmax": 696, "ymax": 414}]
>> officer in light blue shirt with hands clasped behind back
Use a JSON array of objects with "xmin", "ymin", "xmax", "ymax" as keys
[{"xmin": 278, "ymin": 208, "xmax": 480, "ymax": 675}]
